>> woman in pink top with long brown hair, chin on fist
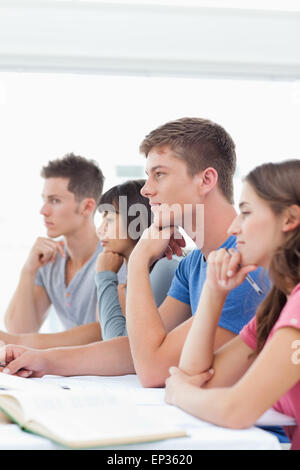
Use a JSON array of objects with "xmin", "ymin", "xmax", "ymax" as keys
[{"xmin": 166, "ymin": 160, "xmax": 300, "ymax": 449}]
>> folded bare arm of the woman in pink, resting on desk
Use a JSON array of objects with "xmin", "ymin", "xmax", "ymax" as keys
[{"xmin": 173, "ymin": 328, "xmax": 300, "ymax": 429}]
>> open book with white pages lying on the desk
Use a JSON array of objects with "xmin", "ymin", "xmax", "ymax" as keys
[{"xmin": 0, "ymin": 373, "xmax": 186, "ymax": 449}]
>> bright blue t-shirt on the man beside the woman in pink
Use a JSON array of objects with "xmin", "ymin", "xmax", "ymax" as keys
[{"xmin": 168, "ymin": 235, "xmax": 270, "ymax": 334}]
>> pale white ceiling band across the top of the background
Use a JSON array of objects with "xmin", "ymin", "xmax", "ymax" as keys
[{"xmin": 0, "ymin": 0, "xmax": 300, "ymax": 80}]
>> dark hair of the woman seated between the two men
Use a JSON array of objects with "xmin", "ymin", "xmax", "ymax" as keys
[{"xmin": 98, "ymin": 179, "xmax": 152, "ymax": 243}]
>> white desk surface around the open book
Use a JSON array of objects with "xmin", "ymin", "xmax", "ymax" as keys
[{"xmin": 0, "ymin": 375, "xmax": 290, "ymax": 450}]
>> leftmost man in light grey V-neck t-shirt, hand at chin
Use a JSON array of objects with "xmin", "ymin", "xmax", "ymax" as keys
[{"xmin": 5, "ymin": 154, "xmax": 104, "ymax": 347}]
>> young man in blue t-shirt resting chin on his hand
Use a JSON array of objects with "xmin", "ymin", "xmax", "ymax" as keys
[{"xmin": 127, "ymin": 118, "xmax": 286, "ymax": 440}]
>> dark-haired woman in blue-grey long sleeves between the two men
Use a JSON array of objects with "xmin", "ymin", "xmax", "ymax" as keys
[{"xmin": 95, "ymin": 180, "xmax": 179, "ymax": 340}]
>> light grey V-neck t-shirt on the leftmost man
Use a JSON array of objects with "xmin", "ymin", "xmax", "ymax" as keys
[{"xmin": 35, "ymin": 243, "xmax": 126, "ymax": 329}]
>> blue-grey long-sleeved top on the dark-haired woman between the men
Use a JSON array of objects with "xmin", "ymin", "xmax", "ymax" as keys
[{"xmin": 95, "ymin": 256, "xmax": 181, "ymax": 340}]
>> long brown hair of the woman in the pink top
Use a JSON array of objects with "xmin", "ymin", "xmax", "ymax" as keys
[{"xmin": 245, "ymin": 159, "xmax": 300, "ymax": 354}]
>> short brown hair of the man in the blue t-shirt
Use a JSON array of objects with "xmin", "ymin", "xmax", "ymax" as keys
[{"xmin": 140, "ymin": 118, "xmax": 236, "ymax": 204}]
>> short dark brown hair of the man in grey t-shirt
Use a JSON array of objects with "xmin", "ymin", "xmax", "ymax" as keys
[{"xmin": 41, "ymin": 153, "xmax": 104, "ymax": 205}]
